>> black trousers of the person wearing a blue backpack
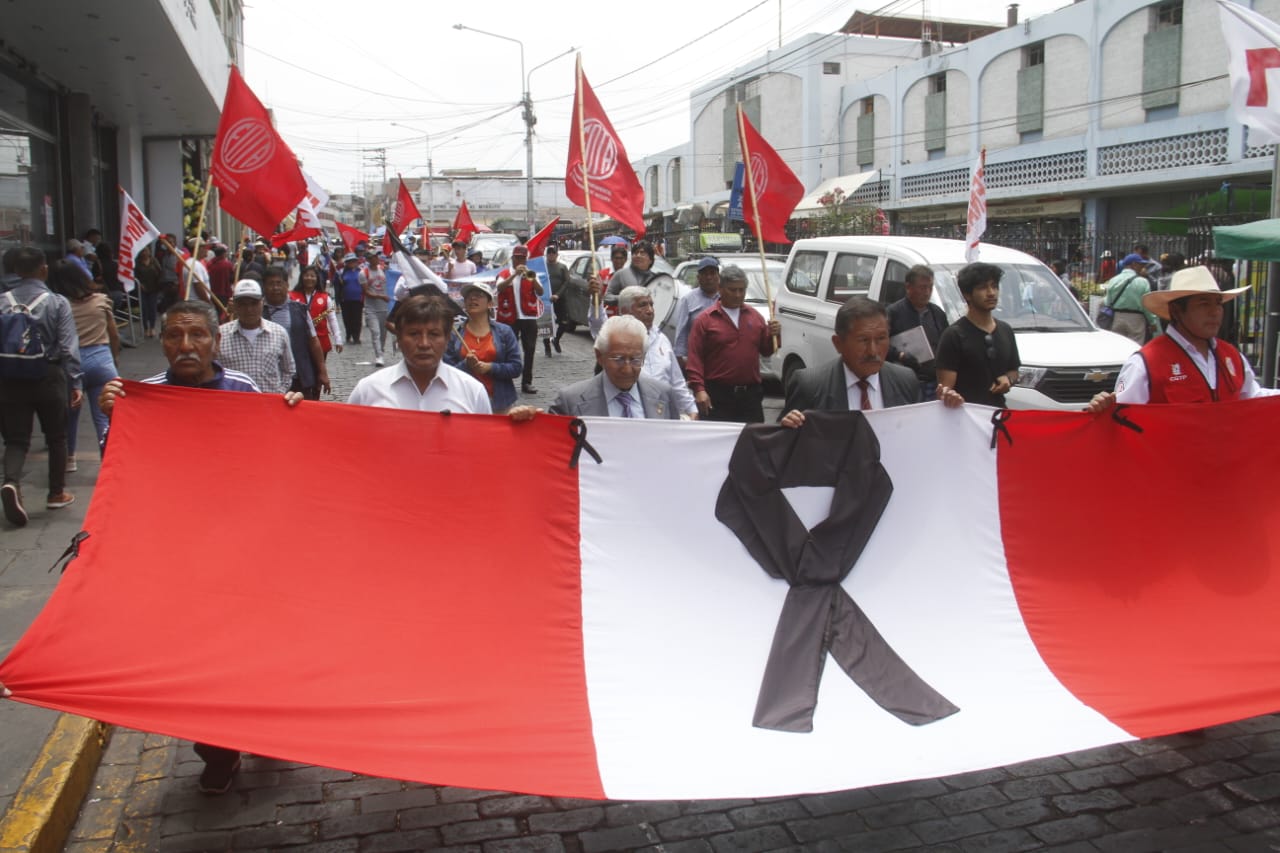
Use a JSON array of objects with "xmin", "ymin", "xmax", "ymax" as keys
[{"xmin": 0, "ymin": 362, "xmax": 68, "ymax": 496}]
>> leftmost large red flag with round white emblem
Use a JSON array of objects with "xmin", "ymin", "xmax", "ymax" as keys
[{"xmin": 210, "ymin": 65, "xmax": 307, "ymax": 234}]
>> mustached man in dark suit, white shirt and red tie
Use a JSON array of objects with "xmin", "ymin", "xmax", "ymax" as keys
[{"xmin": 782, "ymin": 296, "xmax": 963, "ymax": 427}]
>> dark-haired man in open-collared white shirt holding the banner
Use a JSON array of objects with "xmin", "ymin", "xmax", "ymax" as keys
[{"xmin": 347, "ymin": 296, "xmax": 493, "ymax": 415}]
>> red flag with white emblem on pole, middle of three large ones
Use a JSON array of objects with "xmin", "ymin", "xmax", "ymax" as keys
[{"xmin": 564, "ymin": 55, "xmax": 644, "ymax": 237}]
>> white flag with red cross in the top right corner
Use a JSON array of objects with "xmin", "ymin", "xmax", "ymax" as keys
[{"xmin": 1217, "ymin": 0, "xmax": 1280, "ymax": 145}]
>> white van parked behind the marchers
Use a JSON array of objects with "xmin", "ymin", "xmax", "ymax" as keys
[{"xmin": 777, "ymin": 236, "xmax": 1138, "ymax": 410}]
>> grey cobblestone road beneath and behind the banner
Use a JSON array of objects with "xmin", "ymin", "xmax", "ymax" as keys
[{"xmin": 30, "ymin": 324, "xmax": 1280, "ymax": 853}]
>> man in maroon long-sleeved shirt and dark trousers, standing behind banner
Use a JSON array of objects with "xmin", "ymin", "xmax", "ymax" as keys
[{"xmin": 686, "ymin": 265, "xmax": 782, "ymax": 424}]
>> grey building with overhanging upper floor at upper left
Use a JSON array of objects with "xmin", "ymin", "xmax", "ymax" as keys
[{"xmin": 0, "ymin": 0, "xmax": 243, "ymax": 255}]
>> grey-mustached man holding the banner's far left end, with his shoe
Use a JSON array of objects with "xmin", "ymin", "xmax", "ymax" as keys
[{"xmin": 97, "ymin": 300, "xmax": 302, "ymax": 795}]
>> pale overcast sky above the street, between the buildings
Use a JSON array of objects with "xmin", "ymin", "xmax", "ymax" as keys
[{"xmin": 244, "ymin": 0, "xmax": 1064, "ymax": 193}]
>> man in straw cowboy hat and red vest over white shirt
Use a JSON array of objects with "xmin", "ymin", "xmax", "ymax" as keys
[{"xmin": 1088, "ymin": 266, "xmax": 1280, "ymax": 412}]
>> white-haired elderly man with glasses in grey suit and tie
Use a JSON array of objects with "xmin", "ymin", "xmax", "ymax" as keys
[{"xmin": 548, "ymin": 315, "xmax": 680, "ymax": 419}]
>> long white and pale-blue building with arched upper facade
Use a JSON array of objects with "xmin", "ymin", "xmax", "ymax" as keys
[{"xmin": 632, "ymin": 0, "xmax": 1280, "ymax": 254}]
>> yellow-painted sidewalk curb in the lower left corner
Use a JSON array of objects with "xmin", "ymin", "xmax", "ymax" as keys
[{"xmin": 0, "ymin": 713, "xmax": 111, "ymax": 853}]
